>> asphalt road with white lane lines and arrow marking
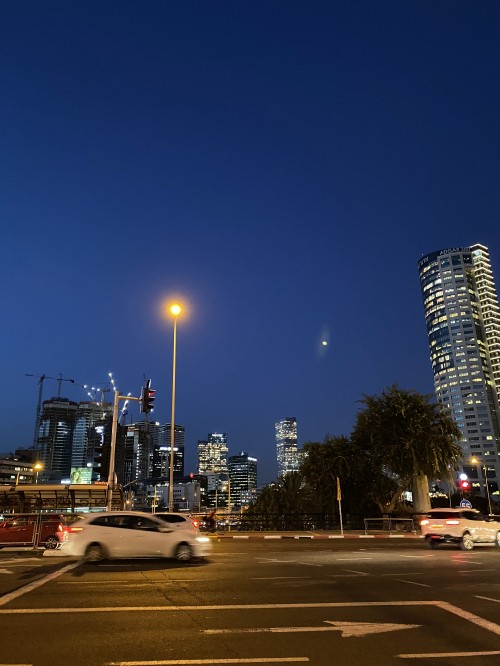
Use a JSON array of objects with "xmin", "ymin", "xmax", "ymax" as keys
[{"xmin": 0, "ymin": 539, "xmax": 500, "ymax": 666}]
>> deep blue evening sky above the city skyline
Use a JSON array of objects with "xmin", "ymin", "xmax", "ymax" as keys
[{"xmin": 0, "ymin": 0, "xmax": 500, "ymax": 483}]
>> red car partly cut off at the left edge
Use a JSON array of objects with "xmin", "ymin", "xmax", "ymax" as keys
[{"xmin": 0, "ymin": 513, "xmax": 68, "ymax": 549}]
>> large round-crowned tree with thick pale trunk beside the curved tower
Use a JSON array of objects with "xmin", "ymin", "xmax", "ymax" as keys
[{"xmin": 352, "ymin": 386, "xmax": 462, "ymax": 513}]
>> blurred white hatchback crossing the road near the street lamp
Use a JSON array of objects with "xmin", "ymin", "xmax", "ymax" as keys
[{"xmin": 61, "ymin": 511, "xmax": 212, "ymax": 562}]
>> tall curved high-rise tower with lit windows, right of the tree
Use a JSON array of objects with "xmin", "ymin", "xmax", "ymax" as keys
[{"xmin": 418, "ymin": 244, "xmax": 500, "ymax": 496}]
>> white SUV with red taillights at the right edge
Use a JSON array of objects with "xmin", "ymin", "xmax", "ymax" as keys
[{"xmin": 420, "ymin": 508, "xmax": 500, "ymax": 550}]
